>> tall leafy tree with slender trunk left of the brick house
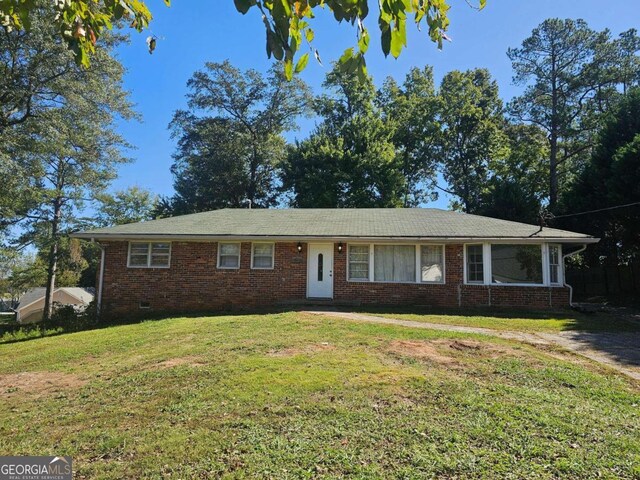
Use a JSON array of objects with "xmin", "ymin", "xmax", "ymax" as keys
[{"xmin": 0, "ymin": 3, "xmax": 133, "ymax": 318}]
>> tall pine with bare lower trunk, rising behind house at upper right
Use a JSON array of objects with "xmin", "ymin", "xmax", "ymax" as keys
[{"xmin": 508, "ymin": 19, "xmax": 639, "ymax": 209}]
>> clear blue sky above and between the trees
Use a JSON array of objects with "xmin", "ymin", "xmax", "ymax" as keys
[{"xmin": 112, "ymin": 0, "xmax": 640, "ymax": 208}]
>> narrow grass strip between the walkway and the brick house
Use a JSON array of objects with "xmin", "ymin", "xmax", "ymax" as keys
[{"xmin": 363, "ymin": 308, "xmax": 640, "ymax": 333}]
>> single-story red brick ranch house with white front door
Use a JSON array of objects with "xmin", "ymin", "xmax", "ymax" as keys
[{"xmin": 73, "ymin": 208, "xmax": 598, "ymax": 315}]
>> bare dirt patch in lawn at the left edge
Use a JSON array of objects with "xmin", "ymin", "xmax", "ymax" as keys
[{"xmin": 0, "ymin": 372, "xmax": 87, "ymax": 398}]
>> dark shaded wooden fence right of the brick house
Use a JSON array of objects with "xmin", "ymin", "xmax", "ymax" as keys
[{"xmin": 566, "ymin": 262, "xmax": 640, "ymax": 296}]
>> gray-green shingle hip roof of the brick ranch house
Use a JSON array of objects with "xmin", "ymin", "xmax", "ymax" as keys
[{"xmin": 74, "ymin": 208, "xmax": 596, "ymax": 242}]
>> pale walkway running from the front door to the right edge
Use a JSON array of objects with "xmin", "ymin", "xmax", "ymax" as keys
[{"xmin": 305, "ymin": 310, "xmax": 640, "ymax": 380}]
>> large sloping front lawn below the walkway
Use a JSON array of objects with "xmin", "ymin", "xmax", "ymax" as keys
[{"xmin": 0, "ymin": 313, "xmax": 640, "ymax": 479}]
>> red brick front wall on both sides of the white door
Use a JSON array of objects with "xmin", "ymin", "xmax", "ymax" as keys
[{"xmin": 102, "ymin": 242, "xmax": 569, "ymax": 315}]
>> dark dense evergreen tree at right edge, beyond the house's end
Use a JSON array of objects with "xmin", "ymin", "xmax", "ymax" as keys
[{"xmin": 554, "ymin": 87, "xmax": 640, "ymax": 264}]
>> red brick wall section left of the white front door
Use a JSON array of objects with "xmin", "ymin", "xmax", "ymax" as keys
[{"xmin": 102, "ymin": 242, "xmax": 307, "ymax": 315}]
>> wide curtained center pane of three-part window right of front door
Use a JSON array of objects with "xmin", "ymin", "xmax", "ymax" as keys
[{"xmin": 373, "ymin": 245, "xmax": 416, "ymax": 282}]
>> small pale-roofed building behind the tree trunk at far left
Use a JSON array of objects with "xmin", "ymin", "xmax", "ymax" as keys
[{"xmin": 16, "ymin": 287, "xmax": 94, "ymax": 324}]
